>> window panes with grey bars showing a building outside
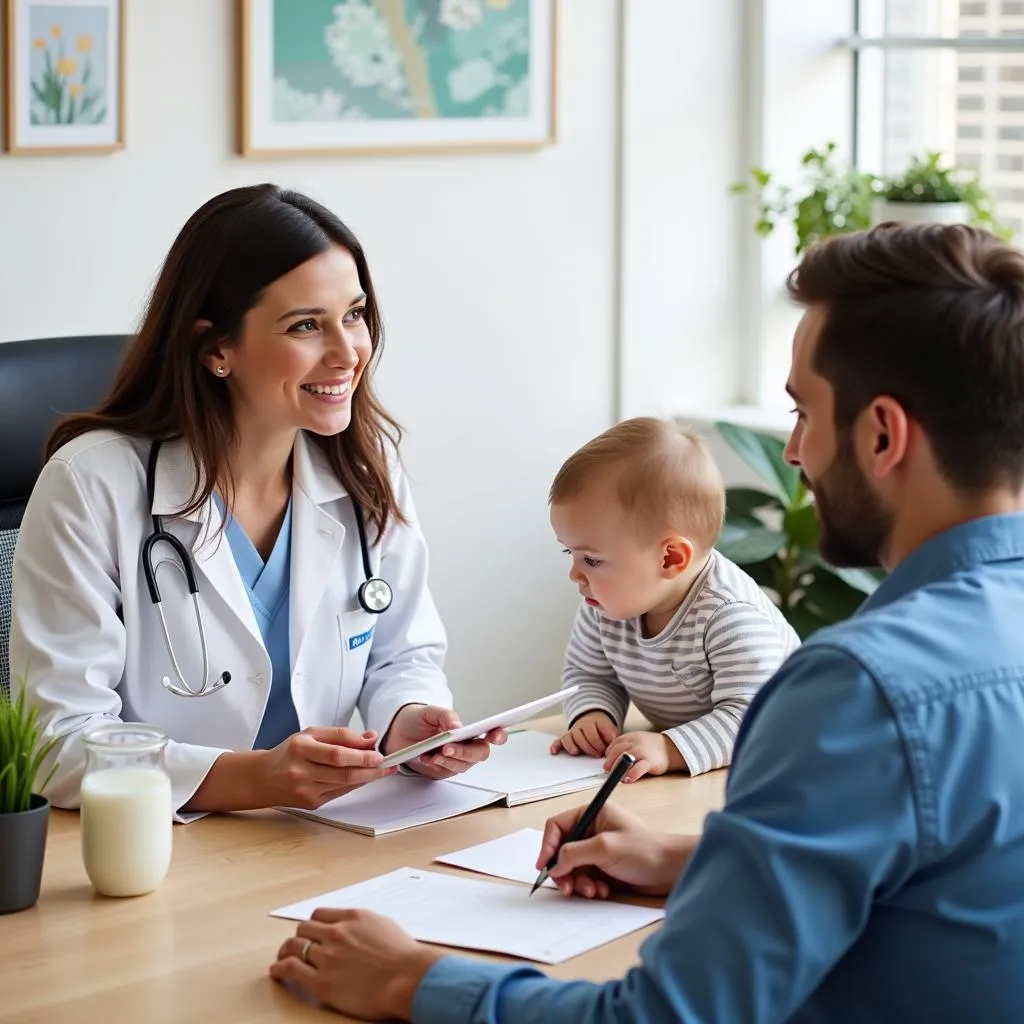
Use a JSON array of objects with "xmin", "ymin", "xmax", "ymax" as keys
[{"xmin": 851, "ymin": 0, "xmax": 1024, "ymax": 234}]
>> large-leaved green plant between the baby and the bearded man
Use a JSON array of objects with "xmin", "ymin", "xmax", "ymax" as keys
[{"xmin": 715, "ymin": 423, "xmax": 882, "ymax": 639}]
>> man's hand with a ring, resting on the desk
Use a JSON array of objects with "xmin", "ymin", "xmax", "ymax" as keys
[{"xmin": 270, "ymin": 908, "xmax": 443, "ymax": 1021}]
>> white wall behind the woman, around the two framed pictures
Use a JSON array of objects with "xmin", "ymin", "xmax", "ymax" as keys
[{"xmin": 0, "ymin": 0, "xmax": 614, "ymax": 715}]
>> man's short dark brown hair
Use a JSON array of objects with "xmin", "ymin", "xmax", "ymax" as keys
[{"xmin": 787, "ymin": 223, "xmax": 1024, "ymax": 494}]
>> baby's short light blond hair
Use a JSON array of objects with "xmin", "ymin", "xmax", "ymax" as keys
[{"xmin": 548, "ymin": 417, "xmax": 725, "ymax": 549}]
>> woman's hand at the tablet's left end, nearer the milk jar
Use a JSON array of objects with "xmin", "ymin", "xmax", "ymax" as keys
[{"xmin": 260, "ymin": 726, "xmax": 396, "ymax": 811}]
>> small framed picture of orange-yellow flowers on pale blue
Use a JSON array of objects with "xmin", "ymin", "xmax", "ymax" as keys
[{"xmin": 5, "ymin": 0, "xmax": 125, "ymax": 154}]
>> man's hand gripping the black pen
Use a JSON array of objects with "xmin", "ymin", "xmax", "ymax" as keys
[{"xmin": 537, "ymin": 803, "xmax": 699, "ymax": 899}]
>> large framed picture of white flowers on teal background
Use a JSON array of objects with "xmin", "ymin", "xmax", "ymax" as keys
[{"xmin": 237, "ymin": 0, "xmax": 557, "ymax": 156}]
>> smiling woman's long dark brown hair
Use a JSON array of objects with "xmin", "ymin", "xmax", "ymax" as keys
[{"xmin": 46, "ymin": 184, "xmax": 404, "ymax": 536}]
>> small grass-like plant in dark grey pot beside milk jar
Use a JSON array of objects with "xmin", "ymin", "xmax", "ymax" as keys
[{"xmin": 0, "ymin": 681, "xmax": 56, "ymax": 913}]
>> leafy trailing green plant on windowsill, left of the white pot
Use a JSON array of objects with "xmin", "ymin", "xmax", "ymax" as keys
[{"xmin": 730, "ymin": 142, "xmax": 878, "ymax": 256}]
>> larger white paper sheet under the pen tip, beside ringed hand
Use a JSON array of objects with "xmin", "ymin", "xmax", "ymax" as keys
[{"xmin": 271, "ymin": 867, "xmax": 665, "ymax": 964}]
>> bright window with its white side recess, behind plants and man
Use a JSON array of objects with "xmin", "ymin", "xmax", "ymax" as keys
[{"xmin": 734, "ymin": 0, "xmax": 1024, "ymax": 409}]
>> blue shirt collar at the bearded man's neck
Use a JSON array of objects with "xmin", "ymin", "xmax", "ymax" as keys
[{"xmin": 860, "ymin": 512, "xmax": 1024, "ymax": 612}]
